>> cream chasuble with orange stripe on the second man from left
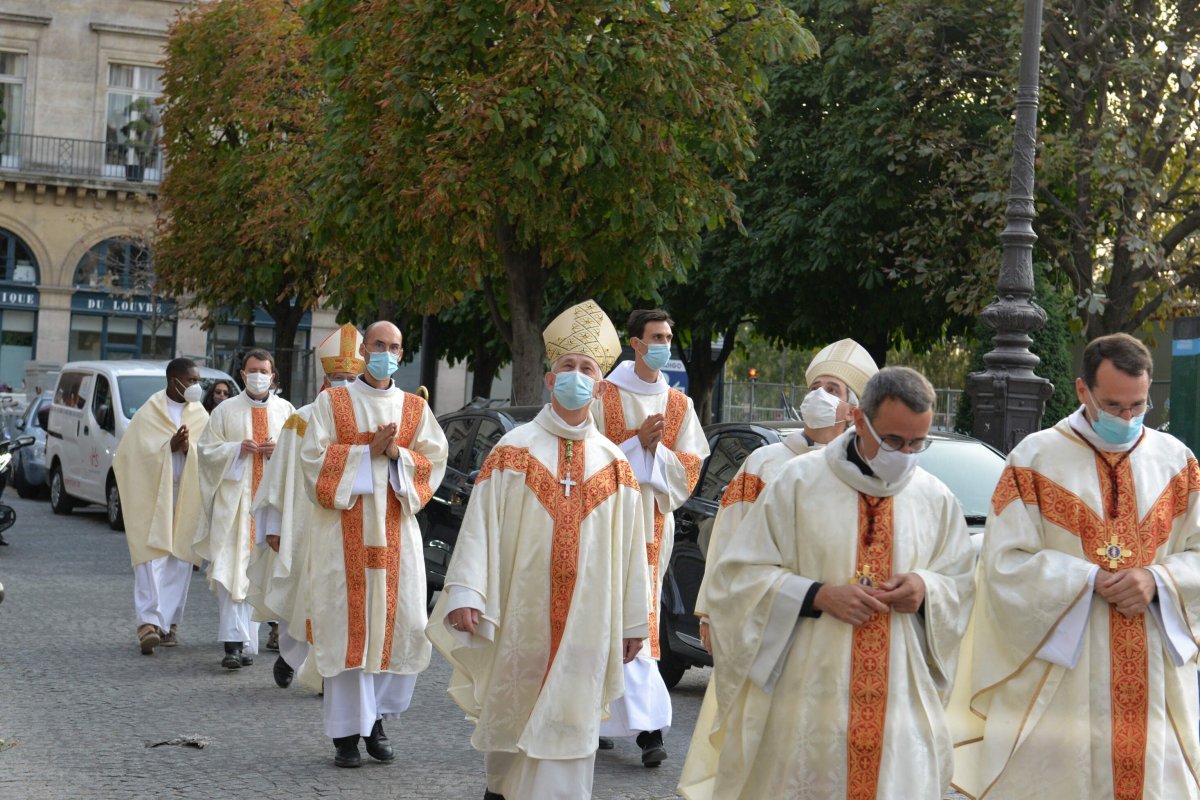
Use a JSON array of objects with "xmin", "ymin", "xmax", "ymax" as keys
[{"xmin": 193, "ymin": 392, "xmax": 294, "ymax": 602}]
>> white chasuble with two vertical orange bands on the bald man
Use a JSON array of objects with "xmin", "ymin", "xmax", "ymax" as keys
[{"xmin": 300, "ymin": 378, "xmax": 448, "ymax": 684}]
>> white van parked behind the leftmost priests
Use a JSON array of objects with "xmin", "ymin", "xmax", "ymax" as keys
[{"xmin": 46, "ymin": 361, "xmax": 238, "ymax": 530}]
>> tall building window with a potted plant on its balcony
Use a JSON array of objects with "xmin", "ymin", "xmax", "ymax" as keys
[{"xmin": 104, "ymin": 64, "xmax": 162, "ymax": 180}]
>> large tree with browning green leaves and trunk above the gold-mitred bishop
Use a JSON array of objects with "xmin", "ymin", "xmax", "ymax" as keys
[{"xmin": 306, "ymin": 0, "xmax": 816, "ymax": 403}]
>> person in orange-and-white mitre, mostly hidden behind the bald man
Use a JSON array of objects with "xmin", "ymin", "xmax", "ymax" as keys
[{"xmin": 247, "ymin": 323, "xmax": 366, "ymax": 688}]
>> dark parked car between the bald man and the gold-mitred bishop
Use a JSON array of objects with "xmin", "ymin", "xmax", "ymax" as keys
[{"xmin": 416, "ymin": 405, "xmax": 541, "ymax": 603}]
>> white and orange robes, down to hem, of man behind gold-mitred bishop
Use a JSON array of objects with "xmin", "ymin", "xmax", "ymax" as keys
[{"xmin": 592, "ymin": 361, "xmax": 708, "ymax": 736}]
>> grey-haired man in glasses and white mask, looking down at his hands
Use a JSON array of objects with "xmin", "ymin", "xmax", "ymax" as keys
[{"xmin": 679, "ymin": 367, "xmax": 974, "ymax": 800}]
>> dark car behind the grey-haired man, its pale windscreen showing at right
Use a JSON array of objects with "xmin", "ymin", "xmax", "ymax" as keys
[{"xmin": 659, "ymin": 421, "xmax": 1004, "ymax": 686}]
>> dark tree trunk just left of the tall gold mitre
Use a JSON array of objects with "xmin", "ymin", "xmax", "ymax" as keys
[{"xmin": 496, "ymin": 219, "xmax": 547, "ymax": 405}]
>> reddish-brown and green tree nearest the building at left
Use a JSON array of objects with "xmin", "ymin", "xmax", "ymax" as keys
[{"xmin": 155, "ymin": 0, "xmax": 344, "ymax": 400}]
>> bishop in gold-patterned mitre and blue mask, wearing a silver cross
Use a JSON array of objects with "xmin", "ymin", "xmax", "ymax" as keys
[{"xmin": 428, "ymin": 301, "xmax": 649, "ymax": 800}]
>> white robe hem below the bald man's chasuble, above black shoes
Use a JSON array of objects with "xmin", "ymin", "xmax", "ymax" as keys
[{"xmin": 321, "ymin": 662, "xmax": 416, "ymax": 739}]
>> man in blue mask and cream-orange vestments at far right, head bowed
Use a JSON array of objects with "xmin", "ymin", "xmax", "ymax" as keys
[{"xmin": 952, "ymin": 333, "xmax": 1200, "ymax": 800}]
